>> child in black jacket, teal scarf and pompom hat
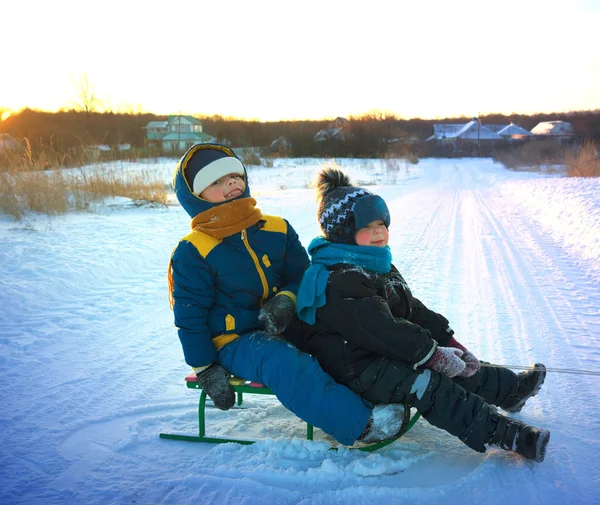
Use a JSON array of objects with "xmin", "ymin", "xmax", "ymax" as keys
[{"xmin": 287, "ymin": 168, "xmax": 550, "ymax": 462}]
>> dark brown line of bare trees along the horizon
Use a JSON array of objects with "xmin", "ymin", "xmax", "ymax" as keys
[{"xmin": 0, "ymin": 109, "xmax": 600, "ymax": 157}]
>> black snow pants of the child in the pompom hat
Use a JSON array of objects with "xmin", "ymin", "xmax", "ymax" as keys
[{"xmin": 343, "ymin": 358, "xmax": 517, "ymax": 452}]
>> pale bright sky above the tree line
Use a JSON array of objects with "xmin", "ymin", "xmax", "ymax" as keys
[{"xmin": 0, "ymin": 0, "xmax": 600, "ymax": 121}]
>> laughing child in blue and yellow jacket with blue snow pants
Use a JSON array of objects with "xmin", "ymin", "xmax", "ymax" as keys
[{"xmin": 169, "ymin": 144, "xmax": 404, "ymax": 445}]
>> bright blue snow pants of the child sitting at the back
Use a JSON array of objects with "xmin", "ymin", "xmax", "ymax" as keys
[{"xmin": 217, "ymin": 331, "xmax": 371, "ymax": 445}]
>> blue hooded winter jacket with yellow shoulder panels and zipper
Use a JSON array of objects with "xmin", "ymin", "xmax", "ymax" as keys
[{"xmin": 171, "ymin": 145, "xmax": 310, "ymax": 367}]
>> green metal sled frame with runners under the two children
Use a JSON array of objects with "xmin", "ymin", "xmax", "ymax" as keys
[{"xmin": 160, "ymin": 373, "xmax": 420, "ymax": 451}]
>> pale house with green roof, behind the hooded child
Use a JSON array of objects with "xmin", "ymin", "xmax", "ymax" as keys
[{"xmin": 144, "ymin": 115, "xmax": 216, "ymax": 153}]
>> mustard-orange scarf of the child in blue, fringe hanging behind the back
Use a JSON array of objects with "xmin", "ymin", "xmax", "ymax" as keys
[{"xmin": 167, "ymin": 198, "xmax": 262, "ymax": 309}]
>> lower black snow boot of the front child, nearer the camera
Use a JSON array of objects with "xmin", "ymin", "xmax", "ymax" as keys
[{"xmin": 487, "ymin": 412, "xmax": 550, "ymax": 463}]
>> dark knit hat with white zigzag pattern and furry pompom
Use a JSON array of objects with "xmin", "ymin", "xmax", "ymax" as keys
[{"xmin": 317, "ymin": 168, "xmax": 390, "ymax": 244}]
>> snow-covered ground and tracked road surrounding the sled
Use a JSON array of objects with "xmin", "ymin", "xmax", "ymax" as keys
[{"xmin": 0, "ymin": 159, "xmax": 600, "ymax": 505}]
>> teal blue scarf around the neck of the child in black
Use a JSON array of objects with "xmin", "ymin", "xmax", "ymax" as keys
[{"xmin": 296, "ymin": 237, "xmax": 392, "ymax": 324}]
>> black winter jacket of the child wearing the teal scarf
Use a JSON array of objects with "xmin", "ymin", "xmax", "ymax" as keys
[{"xmin": 286, "ymin": 264, "xmax": 453, "ymax": 384}]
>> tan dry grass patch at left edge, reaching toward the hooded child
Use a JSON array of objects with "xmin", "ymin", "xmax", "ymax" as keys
[{"xmin": 0, "ymin": 146, "xmax": 168, "ymax": 220}]
